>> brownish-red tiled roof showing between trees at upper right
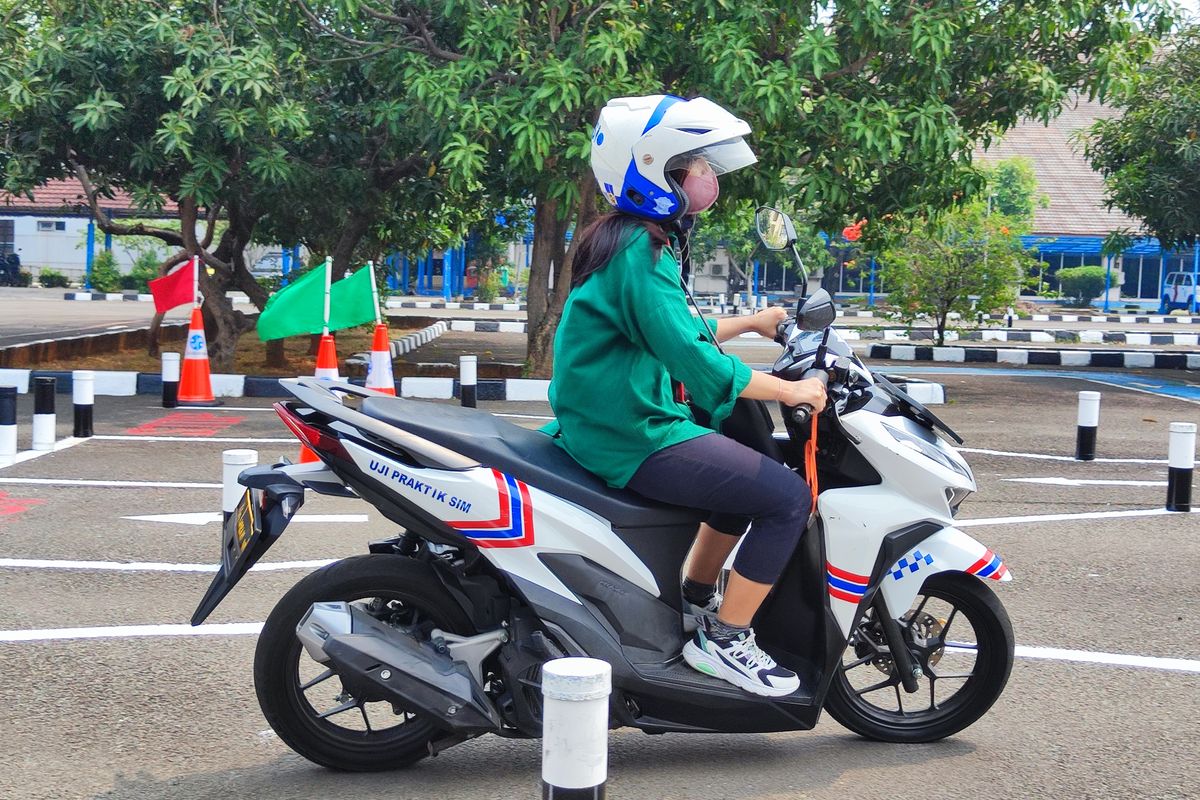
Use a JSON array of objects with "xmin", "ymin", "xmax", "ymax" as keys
[{"xmin": 976, "ymin": 98, "xmax": 1141, "ymax": 236}]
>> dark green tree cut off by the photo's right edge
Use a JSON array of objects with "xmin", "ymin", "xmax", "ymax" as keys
[{"xmin": 1082, "ymin": 26, "xmax": 1200, "ymax": 248}]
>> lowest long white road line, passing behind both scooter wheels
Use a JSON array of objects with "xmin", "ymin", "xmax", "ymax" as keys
[{"xmin": 0, "ymin": 622, "xmax": 1200, "ymax": 673}]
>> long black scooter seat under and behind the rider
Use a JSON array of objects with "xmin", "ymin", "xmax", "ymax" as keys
[{"xmin": 361, "ymin": 397, "xmax": 707, "ymax": 528}]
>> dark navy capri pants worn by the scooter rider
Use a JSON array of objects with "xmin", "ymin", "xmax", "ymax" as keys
[{"xmin": 628, "ymin": 433, "xmax": 812, "ymax": 584}]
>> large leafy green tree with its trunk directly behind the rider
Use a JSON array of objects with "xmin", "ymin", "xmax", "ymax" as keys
[{"xmin": 300, "ymin": 0, "xmax": 1170, "ymax": 374}]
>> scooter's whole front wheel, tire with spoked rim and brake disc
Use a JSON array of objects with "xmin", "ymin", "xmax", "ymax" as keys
[{"xmin": 826, "ymin": 572, "xmax": 1015, "ymax": 742}]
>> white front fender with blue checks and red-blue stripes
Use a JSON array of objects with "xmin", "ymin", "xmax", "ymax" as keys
[{"xmin": 880, "ymin": 528, "xmax": 1013, "ymax": 619}]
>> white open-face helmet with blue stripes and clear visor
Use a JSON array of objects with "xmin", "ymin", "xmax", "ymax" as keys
[{"xmin": 592, "ymin": 95, "xmax": 757, "ymax": 222}]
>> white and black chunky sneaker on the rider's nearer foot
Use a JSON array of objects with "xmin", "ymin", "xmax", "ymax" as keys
[{"xmin": 683, "ymin": 618, "xmax": 800, "ymax": 697}]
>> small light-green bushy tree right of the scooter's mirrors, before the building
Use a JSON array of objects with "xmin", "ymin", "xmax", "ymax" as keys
[{"xmin": 881, "ymin": 199, "xmax": 1037, "ymax": 345}]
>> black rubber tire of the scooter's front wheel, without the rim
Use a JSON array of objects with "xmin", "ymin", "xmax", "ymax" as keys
[{"xmin": 826, "ymin": 572, "xmax": 1015, "ymax": 744}]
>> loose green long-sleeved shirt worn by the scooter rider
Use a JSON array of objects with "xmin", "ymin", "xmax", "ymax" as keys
[{"xmin": 544, "ymin": 228, "xmax": 751, "ymax": 487}]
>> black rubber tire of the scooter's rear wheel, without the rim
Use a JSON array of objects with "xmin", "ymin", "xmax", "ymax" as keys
[{"xmin": 254, "ymin": 554, "xmax": 475, "ymax": 772}]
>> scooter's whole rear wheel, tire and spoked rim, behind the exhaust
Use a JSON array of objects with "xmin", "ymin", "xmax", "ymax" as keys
[{"xmin": 254, "ymin": 554, "xmax": 475, "ymax": 771}]
